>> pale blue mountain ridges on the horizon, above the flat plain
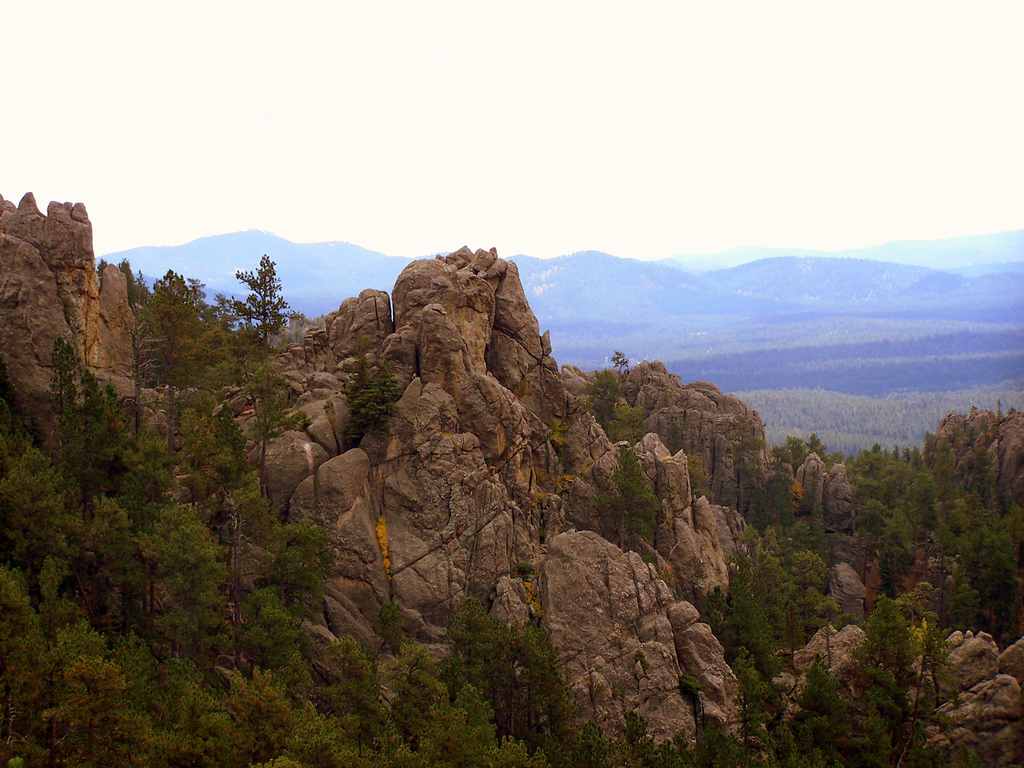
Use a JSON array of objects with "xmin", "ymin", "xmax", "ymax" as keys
[{"xmin": 105, "ymin": 230, "xmax": 1024, "ymax": 323}]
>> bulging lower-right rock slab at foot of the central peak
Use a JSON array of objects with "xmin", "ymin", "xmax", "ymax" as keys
[{"xmin": 540, "ymin": 531, "xmax": 737, "ymax": 740}]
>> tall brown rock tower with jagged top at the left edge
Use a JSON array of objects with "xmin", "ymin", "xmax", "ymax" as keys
[{"xmin": 0, "ymin": 194, "xmax": 134, "ymax": 441}]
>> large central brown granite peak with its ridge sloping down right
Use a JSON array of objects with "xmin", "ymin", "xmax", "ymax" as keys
[{"xmin": 268, "ymin": 249, "xmax": 743, "ymax": 738}]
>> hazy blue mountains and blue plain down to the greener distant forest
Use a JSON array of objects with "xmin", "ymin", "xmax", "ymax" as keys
[{"xmin": 104, "ymin": 231, "xmax": 1024, "ymax": 394}]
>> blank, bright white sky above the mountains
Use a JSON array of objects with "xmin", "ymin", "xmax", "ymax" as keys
[{"xmin": 0, "ymin": 0, "xmax": 1024, "ymax": 258}]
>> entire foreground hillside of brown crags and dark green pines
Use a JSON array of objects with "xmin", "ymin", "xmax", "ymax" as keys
[{"xmin": 0, "ymin": 198, "xmax": 1024, "ymax": 768}]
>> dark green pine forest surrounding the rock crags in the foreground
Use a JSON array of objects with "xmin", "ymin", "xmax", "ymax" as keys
[{"xmin": 0, "ymin": 259, "xmax": 1024, "ymax": 768}]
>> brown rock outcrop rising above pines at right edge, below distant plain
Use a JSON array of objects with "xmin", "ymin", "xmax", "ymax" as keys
[{"xmin": 925, "ymin": 409, "xmax": 1024, "ymax": 507}]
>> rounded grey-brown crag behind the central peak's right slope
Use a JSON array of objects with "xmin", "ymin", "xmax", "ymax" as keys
[{"xmin": 623, "ymin": 362, "xmax": 768, "ymax": 513}]
